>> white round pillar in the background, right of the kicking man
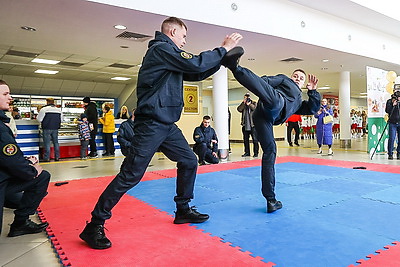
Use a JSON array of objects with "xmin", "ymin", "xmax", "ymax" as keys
[{"xmin": 339, "ymin": 71, "xmax": 351, "ymax": 148}]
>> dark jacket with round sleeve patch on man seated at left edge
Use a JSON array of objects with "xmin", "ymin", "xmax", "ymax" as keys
[{"xmin": 0, "ymin": 110, "xmax": 38, "ymax": 183}]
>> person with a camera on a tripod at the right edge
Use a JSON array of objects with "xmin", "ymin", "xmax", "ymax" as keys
[{"xmin": 385, "ymin": 87, "xmax": 400, "ymax": 159}]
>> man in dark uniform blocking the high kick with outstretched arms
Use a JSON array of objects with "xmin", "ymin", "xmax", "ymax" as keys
[{"xmin": 80, "ymin": 17, "xmax": 242, "ymax": 249}]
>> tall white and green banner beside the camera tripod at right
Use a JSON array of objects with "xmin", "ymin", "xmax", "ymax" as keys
[{"xmin": 367, "ymin": 66, "xmax": 390, "ymax": 155}]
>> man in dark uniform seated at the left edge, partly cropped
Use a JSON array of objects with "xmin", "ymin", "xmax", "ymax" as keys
[{"xmin": 0, "ymin": 80, "xmax": 50, "ymax": 237}]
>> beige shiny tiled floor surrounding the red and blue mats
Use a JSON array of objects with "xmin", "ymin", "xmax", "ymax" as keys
[{"xmin": 0, "ymin": 138, "xmax": 400, "ymax": 267}]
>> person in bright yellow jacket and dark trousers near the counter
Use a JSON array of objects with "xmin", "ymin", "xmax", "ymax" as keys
[{"xmin": 99, "ymin": 105, "xmax": 115, "ymax": 156}]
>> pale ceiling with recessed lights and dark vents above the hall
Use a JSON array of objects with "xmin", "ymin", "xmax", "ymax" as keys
[{"xmin": 0, "ymin": 0, "xmax": 400, "ymax": 98}]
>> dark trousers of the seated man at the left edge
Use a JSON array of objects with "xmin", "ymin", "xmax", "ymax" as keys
[{"xmin": 0, "ymin": 170, "xmax": 50, "ymax": 233}]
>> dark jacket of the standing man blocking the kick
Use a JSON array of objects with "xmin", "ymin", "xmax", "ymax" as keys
[{"xmin": 135, "ymin": 31, "xmax": 226, "ymax": 124}]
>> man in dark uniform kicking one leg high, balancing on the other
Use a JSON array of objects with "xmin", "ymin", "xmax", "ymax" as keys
[{"xmin": 222, "ymin": 47, "xmax": 321, "ymax": 213}]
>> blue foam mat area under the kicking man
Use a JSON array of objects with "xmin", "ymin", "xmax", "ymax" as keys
[{"xmin": 128, "ymin": 162, "xmax": 400, "ymax": 267}]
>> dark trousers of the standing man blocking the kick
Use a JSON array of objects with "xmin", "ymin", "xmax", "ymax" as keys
[{"xmin": 91, "ymin": 118, "xmax": 197, "ymax": 224}]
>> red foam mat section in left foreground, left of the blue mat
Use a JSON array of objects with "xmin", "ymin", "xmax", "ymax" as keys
[{"xmin": 40, "ymin": 174, "xmax": 273, "ymax": 266}]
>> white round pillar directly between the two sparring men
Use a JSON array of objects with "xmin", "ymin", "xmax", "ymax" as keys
[{"xmin": 213, "ymin": 67, "xmax": 229, "ymax": 160}]
